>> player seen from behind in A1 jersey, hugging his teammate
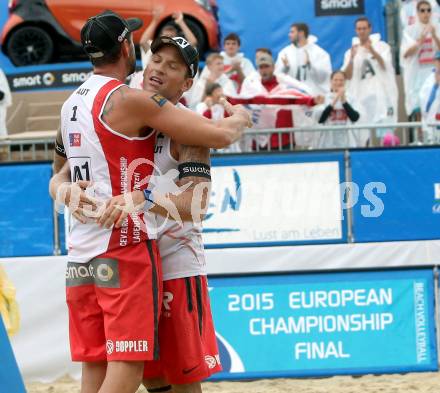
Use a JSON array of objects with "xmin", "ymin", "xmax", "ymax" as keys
[{"xmin": 51, "ymin": 11, "xmax": 249, "ymax": 393}]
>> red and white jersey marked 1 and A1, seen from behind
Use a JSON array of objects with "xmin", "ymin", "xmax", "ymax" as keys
[{"xmin": 61, "ymin": 75, "xmax": 155, "ymax": 263}]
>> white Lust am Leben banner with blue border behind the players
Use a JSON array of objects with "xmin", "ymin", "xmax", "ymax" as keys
[{"xmin": 203, "ymin": 153, "xmax": 346, "ymax": 248}]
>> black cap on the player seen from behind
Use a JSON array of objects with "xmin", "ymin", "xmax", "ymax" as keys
[{"xmin": 81, "ymin": 10, "xmax": 143, "ymax": 59}]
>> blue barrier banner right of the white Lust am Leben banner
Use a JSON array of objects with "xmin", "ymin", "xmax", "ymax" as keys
[{"xmin": 350, "ymin": 148, "xmax": 440, "ymax": 242}]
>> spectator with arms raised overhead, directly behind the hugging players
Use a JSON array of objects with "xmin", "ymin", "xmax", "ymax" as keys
[{"xmin": 130, "ymin": 6, "xmax": 197, "ymax": 89}]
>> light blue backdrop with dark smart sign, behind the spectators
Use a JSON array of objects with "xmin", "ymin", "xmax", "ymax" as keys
[{"xmin": 217, "ymin": 0, "xmax": 386, "ymax": 70}]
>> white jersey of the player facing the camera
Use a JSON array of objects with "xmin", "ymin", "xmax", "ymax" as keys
[{"xmin": 154, "ymin": 128, "xmax": 206, "ymax": 281}]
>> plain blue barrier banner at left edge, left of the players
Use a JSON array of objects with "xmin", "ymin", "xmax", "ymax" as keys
[{"xmin": 0, "ymin": 163, "xmax": 54, "ymax": 257}]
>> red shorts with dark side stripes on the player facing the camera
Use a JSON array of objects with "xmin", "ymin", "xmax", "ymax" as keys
[{"xmin": 144, "ymin": 276, "xmax": 222, "ymax": 385}]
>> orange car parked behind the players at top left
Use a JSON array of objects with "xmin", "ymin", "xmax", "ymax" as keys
[{"xmin": 1, "ymin": 0, "xmax": 218, "ymax": 66}]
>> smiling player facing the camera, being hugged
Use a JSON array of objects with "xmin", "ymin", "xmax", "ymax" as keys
[{"xmin": 102, "ymin": 37, "xmax": 221, "ymax": 393}]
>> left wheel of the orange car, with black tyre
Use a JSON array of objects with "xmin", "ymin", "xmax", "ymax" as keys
[{"xmin": 7, "ymin": 26, "xmax": 53, "ymax": 66}]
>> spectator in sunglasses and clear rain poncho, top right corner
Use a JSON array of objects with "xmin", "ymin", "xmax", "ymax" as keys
[{"xmin": 400, "ymin": 0, "xmax": 440, "ymax": 121}]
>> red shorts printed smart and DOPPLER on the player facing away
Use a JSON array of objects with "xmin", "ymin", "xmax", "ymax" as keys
[{"xmin": 66, "ymin": 240, "xmax": 162, "ymax": 362}]
